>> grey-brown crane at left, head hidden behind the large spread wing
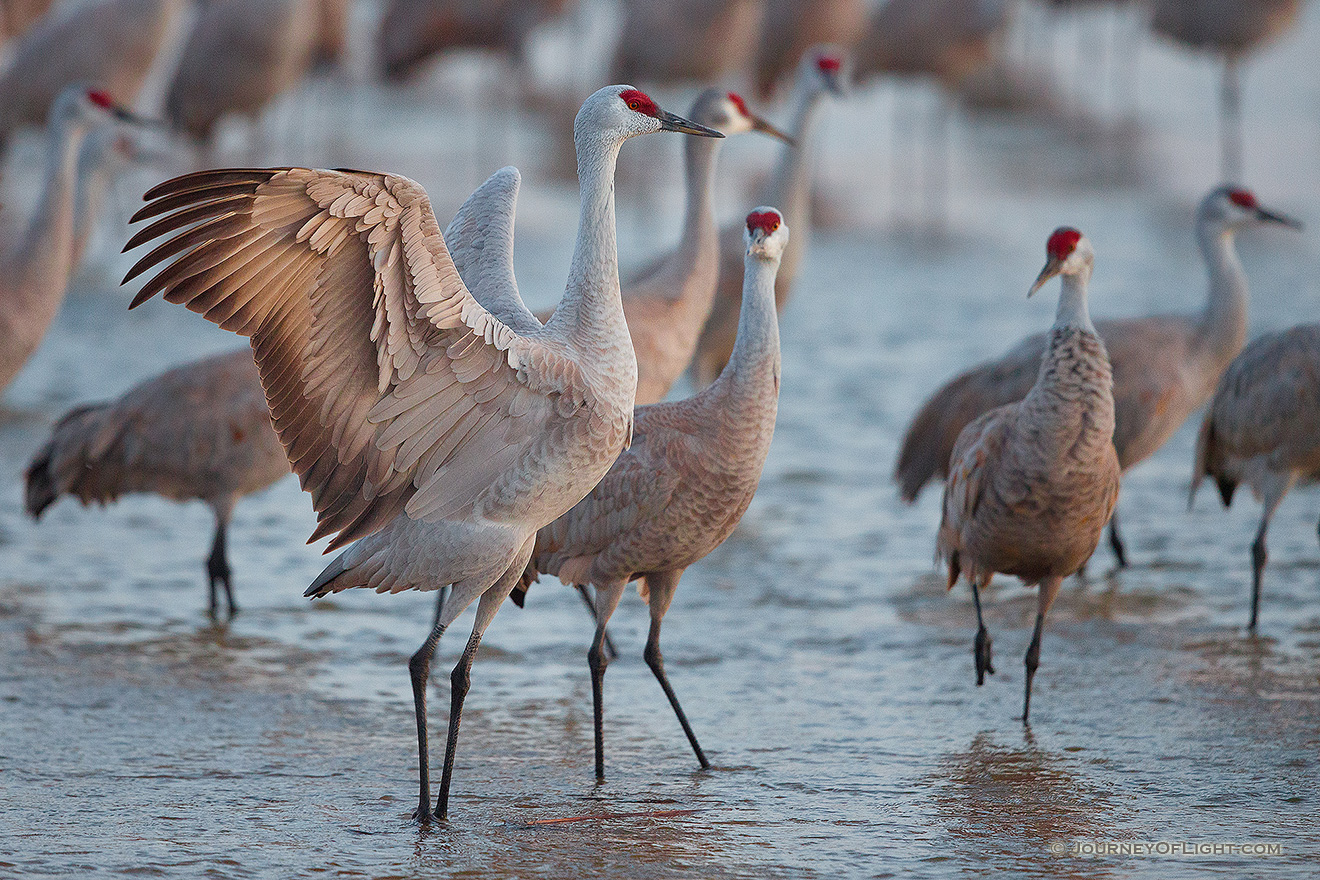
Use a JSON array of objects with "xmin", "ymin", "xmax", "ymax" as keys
[{"xmin": 26, "ymin": 347, "xmax": 289, "ymax": 617}]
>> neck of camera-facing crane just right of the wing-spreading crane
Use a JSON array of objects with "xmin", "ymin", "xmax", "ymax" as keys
[{"xmin": 709, "ymin": 255, "xmax": 780, "ymax": 408}]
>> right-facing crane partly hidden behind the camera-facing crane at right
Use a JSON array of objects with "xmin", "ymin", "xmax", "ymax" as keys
[{"xmin": 894, "ymin": 186, "xmax": 1300, "ymax": 566}]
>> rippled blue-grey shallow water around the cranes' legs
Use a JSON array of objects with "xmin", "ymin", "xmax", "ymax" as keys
[{"xmin": 0, "ymin": 7, "xmax": 1320, "ymax": 877}]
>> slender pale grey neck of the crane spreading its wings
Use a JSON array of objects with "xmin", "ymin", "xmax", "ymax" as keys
[{"xmin": 550, "ymin": 133, "xmax": 636, "ymax": 361}]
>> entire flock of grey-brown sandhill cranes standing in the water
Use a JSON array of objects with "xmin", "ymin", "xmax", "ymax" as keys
[{"xmin": 0, "ymin": 0, "xmax": 1320, "ymax": 823}]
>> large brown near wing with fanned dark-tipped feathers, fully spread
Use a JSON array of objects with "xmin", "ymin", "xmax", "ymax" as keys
[{"xmin": 125, "ymin": 168, "xmax": 590, "ymax": 546}]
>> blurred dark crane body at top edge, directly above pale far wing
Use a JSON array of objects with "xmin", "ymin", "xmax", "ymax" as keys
[{"xmin": 376, "ymin": 0, "xmax": 573, "ymax": 82}]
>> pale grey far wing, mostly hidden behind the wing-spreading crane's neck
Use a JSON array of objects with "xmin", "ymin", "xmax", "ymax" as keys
[{"xmin": 445, "ymin": 165, "xmax": 541, "ymax": 334}]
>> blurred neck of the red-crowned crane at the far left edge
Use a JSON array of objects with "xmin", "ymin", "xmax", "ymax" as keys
[{"xmin": 10, "ymin": 116, "xmax": 86, "ymax": 310}]
